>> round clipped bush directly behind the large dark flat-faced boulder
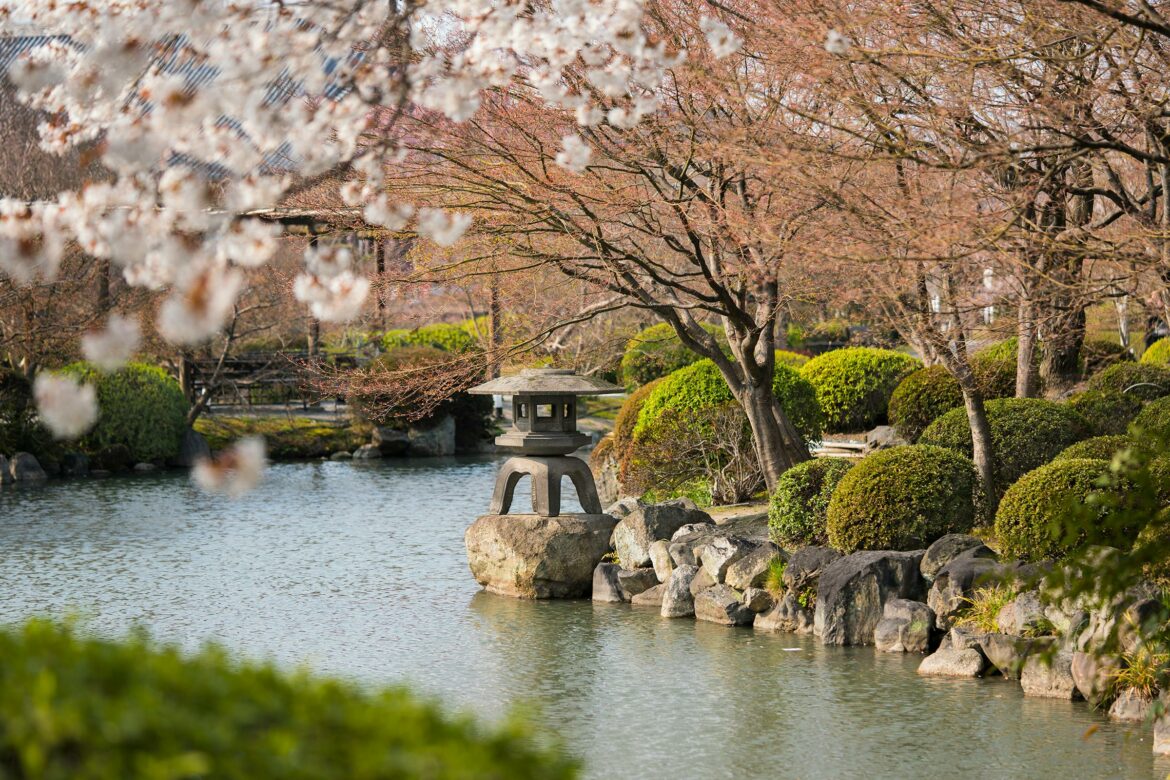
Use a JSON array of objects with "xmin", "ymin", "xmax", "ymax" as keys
[{"xmin": 827, "ymin": 444, "xmax": 977, "ymax": 553}]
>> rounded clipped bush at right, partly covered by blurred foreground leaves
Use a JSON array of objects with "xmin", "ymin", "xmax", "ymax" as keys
[{"xmin": 996, "ymin": 458, "xmax": 1109, "ymax": 560}]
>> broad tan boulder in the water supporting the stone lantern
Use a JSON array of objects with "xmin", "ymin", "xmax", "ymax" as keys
[{"xmin": 463, "ymin": 515, "xmax": 615, "ymax": 599}]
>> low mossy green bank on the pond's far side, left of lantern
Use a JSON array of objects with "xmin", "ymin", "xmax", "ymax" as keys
[{"xmin": 195, "ymin": 414, "xmax": 371, "ymax": 461}]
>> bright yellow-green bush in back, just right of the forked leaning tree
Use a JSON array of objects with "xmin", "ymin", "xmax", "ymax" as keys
[{"xmin": 800, "ymin": 347, "xmax": 922, "ymax": 432}]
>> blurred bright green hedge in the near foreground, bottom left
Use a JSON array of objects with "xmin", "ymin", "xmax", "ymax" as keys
[{"xmin": 0, "ymin": 620, "xmax": 577, "ymax": 780}]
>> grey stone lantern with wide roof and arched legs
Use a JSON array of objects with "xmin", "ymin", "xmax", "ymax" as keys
[{"xmin": 468, "ymin": 368, "xmax": 622, "ymax": 517}]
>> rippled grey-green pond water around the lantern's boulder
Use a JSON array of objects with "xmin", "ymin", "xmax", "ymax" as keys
[{"xmin": 0, "ymin": 457, "xmax": 1170, "ymax": 778}]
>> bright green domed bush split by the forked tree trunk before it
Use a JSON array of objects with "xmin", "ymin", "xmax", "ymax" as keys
[{"xmin": 634, "ymin": 359, "xmax": 821, "ymax": 441}]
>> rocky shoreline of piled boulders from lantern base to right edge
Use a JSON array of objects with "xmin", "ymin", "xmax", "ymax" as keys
[{"xmin": 467, "ymin": 498, "xmax": 1170, "ymax": 755}]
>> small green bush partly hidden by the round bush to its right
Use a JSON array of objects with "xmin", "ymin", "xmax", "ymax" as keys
[{"xmin": 768, "ymin": 457, "xmax": 853, "ymax": 548}]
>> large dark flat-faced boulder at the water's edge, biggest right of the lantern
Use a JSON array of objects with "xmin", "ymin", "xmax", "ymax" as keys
[{"xmin": 813, "ymin": 550, "xmax": 924, "ymax": 644}]
